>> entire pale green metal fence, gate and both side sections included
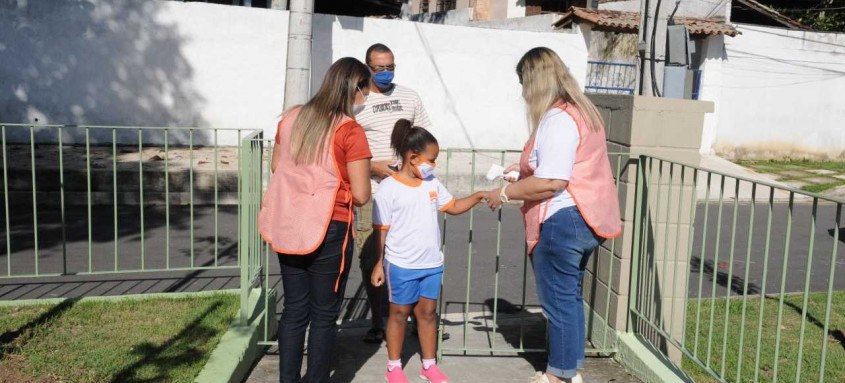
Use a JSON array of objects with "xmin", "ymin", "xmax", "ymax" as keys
[{"xmin": 14, "ymin": 124, "xmax": 845, "ymax": 382}]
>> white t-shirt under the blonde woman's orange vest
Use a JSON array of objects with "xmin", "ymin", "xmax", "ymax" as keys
[{"xmin": 528, "ymin": 108, "xmax": 581, "ymax": 222}]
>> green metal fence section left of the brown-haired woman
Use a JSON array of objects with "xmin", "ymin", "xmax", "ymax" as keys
[{"xmin": 0, "ymin": 124, "xmax": 257, "ymax": 279}]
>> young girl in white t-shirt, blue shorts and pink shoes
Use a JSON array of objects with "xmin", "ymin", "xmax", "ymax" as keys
[{"xmin": 371, "ymin": 120, "xmax": 486, "ymax": 383}]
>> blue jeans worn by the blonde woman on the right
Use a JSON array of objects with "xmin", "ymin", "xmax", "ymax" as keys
[{"xmin": 531, "ymin": 206, "xmax": 602, "ymax": 378}]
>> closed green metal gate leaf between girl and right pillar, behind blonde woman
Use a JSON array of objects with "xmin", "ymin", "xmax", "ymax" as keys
[{"xmin": 438, "ymin": 149, "xmax": 629, "ymax": 357}]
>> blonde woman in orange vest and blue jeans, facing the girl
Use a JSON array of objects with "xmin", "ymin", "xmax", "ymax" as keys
[{"xmin": 488, "ymin": 48, "xmax": 622, "ymax": 383}]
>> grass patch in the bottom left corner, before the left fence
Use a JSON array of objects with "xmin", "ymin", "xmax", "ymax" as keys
[{"xmin": 0, "ymin": 294, "xmax": 238, "ymax": 383}]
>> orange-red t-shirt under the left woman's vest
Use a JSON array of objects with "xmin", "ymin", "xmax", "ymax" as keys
[{"xmin": 276, "ymin": 121, "xmax": 373, "ymax": 222}]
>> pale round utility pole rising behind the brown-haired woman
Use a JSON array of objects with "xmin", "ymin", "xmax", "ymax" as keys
[{"xmin": 284, "ymin": 0, "xmax": 314, "ymax": 110}]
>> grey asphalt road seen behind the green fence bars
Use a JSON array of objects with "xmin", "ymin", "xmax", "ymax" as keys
[{"xmin": 0, "ymin": 201, "xmax": 845, "ymax": 318}]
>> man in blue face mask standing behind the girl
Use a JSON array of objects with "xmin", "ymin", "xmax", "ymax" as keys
[{"xmin": 355, "ymin": 43, "xmax": 431, "ymax": 343}]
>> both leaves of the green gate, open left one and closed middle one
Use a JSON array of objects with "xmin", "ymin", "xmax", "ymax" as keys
[{"xmin": 239, "ymin": 146, "xmax": 630, "ymax": 357}]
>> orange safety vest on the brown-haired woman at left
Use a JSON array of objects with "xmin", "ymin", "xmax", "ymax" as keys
[{"xmin": 258, "ymin": 107, "xmax": 353, "ymax": 291}]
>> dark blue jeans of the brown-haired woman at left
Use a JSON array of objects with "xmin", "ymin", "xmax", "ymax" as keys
[{"xmin": 278, "ymin": 221, "xmax": 353, "ymax": 383}]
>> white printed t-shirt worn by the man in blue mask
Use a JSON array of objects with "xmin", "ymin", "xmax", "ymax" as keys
[{"xmin": 355, "ymin": 84, "xmax": 431, "ymax": 161}]
